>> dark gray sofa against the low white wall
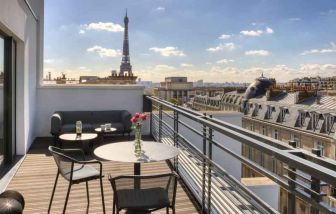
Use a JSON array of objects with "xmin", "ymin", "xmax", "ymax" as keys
[{"xmin": 50, "ymin": 110, "xmax": 132, "ymax": 142}]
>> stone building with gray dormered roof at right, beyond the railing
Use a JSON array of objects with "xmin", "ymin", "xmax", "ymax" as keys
[{"xmin": 242, "ymin": 90, "xmax": 336, "ymax": 213}]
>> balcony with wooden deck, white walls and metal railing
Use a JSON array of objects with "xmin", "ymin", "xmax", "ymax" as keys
[{"xmin": 0, "ymin": 0, "xmax": 336, "ymax": 214}]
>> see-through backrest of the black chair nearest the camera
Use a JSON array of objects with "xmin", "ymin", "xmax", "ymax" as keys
[{"xmin": 109, "ymin": 172, "xmax": 179, "ymax": 205}]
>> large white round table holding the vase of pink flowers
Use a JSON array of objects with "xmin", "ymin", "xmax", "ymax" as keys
[{"xmin": 94, "ymin": 141, "xmax": 179, "ymax": 175}]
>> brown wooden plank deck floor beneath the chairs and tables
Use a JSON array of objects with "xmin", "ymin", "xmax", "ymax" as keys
[{"xmin": 7, "ymin": 139, "xmax": 198, "ymax": 213}]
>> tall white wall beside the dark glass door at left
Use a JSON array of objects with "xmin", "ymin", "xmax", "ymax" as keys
[{"xmin": 0, "ymin": 0, "xmax": 44, "ymax": 154}]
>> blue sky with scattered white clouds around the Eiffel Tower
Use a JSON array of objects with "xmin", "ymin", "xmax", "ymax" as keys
[{"xmin": 44, "ymin": 0, "xmax": 336, "ymax": 82}]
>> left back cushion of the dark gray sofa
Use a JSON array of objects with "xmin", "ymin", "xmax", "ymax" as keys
[{"xmin": 60, "ymin": 111, "xmax": 92, "ymax": 124}]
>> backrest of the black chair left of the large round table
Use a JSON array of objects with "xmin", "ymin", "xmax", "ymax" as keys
[{"xmin": 48, "ymin": 146, "xmax": 80, "ymax": 180}]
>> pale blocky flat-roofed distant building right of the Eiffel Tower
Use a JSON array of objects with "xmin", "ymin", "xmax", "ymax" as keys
[{"xmin": 154, "ymin": 77, "xmax": 194, "ymax": 102}]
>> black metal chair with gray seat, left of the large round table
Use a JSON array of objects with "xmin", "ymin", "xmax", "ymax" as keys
[{"xmin": 48, "ymin": 146, "xmax": 105, "ymax": 213}]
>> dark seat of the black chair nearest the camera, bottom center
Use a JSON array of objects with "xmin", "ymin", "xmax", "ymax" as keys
[{"xmin": 117, "ymin": 188, "xmax": 169, "ymax": 210}]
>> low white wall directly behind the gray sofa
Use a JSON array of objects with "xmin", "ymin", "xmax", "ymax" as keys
[{"xmin": 34, "ymin": 85, "xmax": 146, "ymax": 137}]
